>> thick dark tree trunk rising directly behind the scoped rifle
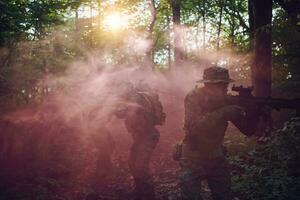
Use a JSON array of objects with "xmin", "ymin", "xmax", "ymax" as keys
[{"xmin": 251, "ymin": 0, "xmax": 272, "ymax": 96}]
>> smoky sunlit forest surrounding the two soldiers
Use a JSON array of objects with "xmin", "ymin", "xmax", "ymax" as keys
[{"xmin": 0, "ymin": 0, "xmax": 300, "ymax": 200}]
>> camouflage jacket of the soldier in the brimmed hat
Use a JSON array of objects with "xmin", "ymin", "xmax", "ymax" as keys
[{"xmin": 183, "ymin": 88, "xmax": 255, "ymax": 155}]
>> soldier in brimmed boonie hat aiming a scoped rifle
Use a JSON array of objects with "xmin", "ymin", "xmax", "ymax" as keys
[{"xmin": 173, "ymin": 66, "xmax": 258, "ymax": 200}]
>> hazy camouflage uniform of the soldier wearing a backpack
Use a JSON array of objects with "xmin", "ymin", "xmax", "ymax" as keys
[{"xmin": 119, "ymin": 83, "xmax": 165, "ymax": 200}]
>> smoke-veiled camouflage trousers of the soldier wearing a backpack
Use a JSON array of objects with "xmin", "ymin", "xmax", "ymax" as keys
[{"xmin": 129, "ymin": 134, "xmax": 159, "ymax": 200}]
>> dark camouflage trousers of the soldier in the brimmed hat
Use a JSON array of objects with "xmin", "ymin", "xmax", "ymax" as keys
[{"xmin": 180, "ymin": 157, "xmax": 232, "ymax": 200}]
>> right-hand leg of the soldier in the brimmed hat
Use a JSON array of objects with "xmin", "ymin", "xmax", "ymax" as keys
[{"xmin": 208, "ymin": 159, "xmax": 232, "ymax": 200}]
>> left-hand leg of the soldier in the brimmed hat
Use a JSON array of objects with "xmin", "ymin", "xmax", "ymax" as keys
[{"xmin": 179, "ymin": 168, "xmax": 202, "ymax": 200}]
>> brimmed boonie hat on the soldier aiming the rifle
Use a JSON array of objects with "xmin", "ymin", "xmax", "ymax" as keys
[{"xmin": 197, "ymin": 65, "xmax": 234, "ymax": 83}]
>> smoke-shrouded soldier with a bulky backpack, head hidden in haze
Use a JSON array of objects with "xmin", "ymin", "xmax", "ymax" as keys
[{"xmin": 116, "ymin": 83, "xmax": 165, "ymax": 200}]
